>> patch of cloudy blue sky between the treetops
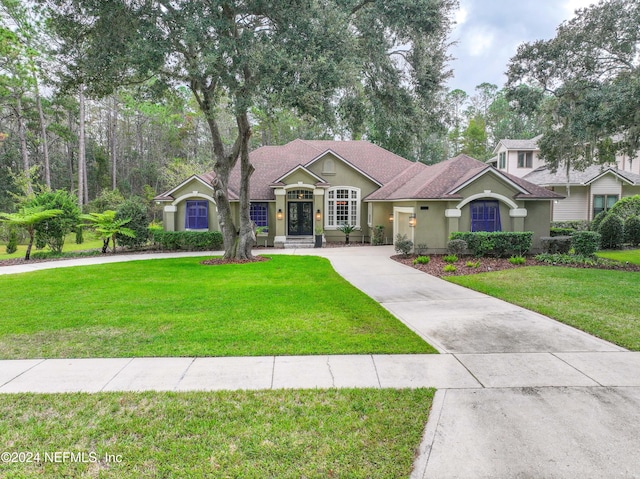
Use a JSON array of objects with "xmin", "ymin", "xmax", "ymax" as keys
[{"xmin": 447, "ymin": 0, "xmax": 596, "ymax": 95}]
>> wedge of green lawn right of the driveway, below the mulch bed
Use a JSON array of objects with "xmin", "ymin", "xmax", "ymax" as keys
[{"xmin": 446, "ymin": 266, "xmax": 640, "ymax": 351}]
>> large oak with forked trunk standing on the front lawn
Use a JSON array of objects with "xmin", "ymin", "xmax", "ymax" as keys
[{"xmin": 41, "ymin": 0, "xmax": 455, "ymax": 258}]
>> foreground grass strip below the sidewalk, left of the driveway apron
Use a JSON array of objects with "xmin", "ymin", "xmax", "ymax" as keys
[{"xmin": 0, "ymin": 389, "xmax": 434, "ymax": 479}]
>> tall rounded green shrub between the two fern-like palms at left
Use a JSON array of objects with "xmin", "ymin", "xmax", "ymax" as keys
[{"xmin": 28, "ymin": 190, "xmax": 80, "ymax": 253}]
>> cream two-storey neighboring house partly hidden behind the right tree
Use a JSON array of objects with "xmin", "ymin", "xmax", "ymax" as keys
[{"xmin": 487, "ymin": 136, "xmax": 640, "ymax": 221}]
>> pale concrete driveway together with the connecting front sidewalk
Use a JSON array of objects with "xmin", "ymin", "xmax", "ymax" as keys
[{"xmin": 0, "ymin": 246, "xmax": 640, "ymax": 479}]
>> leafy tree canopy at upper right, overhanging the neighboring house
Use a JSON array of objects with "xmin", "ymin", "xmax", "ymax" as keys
[{"xmin": 507, "ymin": 0, "xmax": 640, "ymax": 169}]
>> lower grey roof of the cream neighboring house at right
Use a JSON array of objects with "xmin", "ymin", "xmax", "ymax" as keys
[{"xmin": 524, "ymin": 165, "xmax": 640, "ymax": 186}]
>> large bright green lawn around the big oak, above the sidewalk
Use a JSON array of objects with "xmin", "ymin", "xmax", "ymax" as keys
[{"xmin": 0, "ymin": 255, "xmax": 435, "ymax": 359}]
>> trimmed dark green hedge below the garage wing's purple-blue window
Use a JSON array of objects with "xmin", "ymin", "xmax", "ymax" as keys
[{"xmin": 449, "ymin": 231, "xmax": 533, "ymax": 258}]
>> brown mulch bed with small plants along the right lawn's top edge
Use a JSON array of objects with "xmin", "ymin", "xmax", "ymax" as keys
[{"xmin": 391, "ymin": 255, "xmax": 640, "ymax": 278}]
